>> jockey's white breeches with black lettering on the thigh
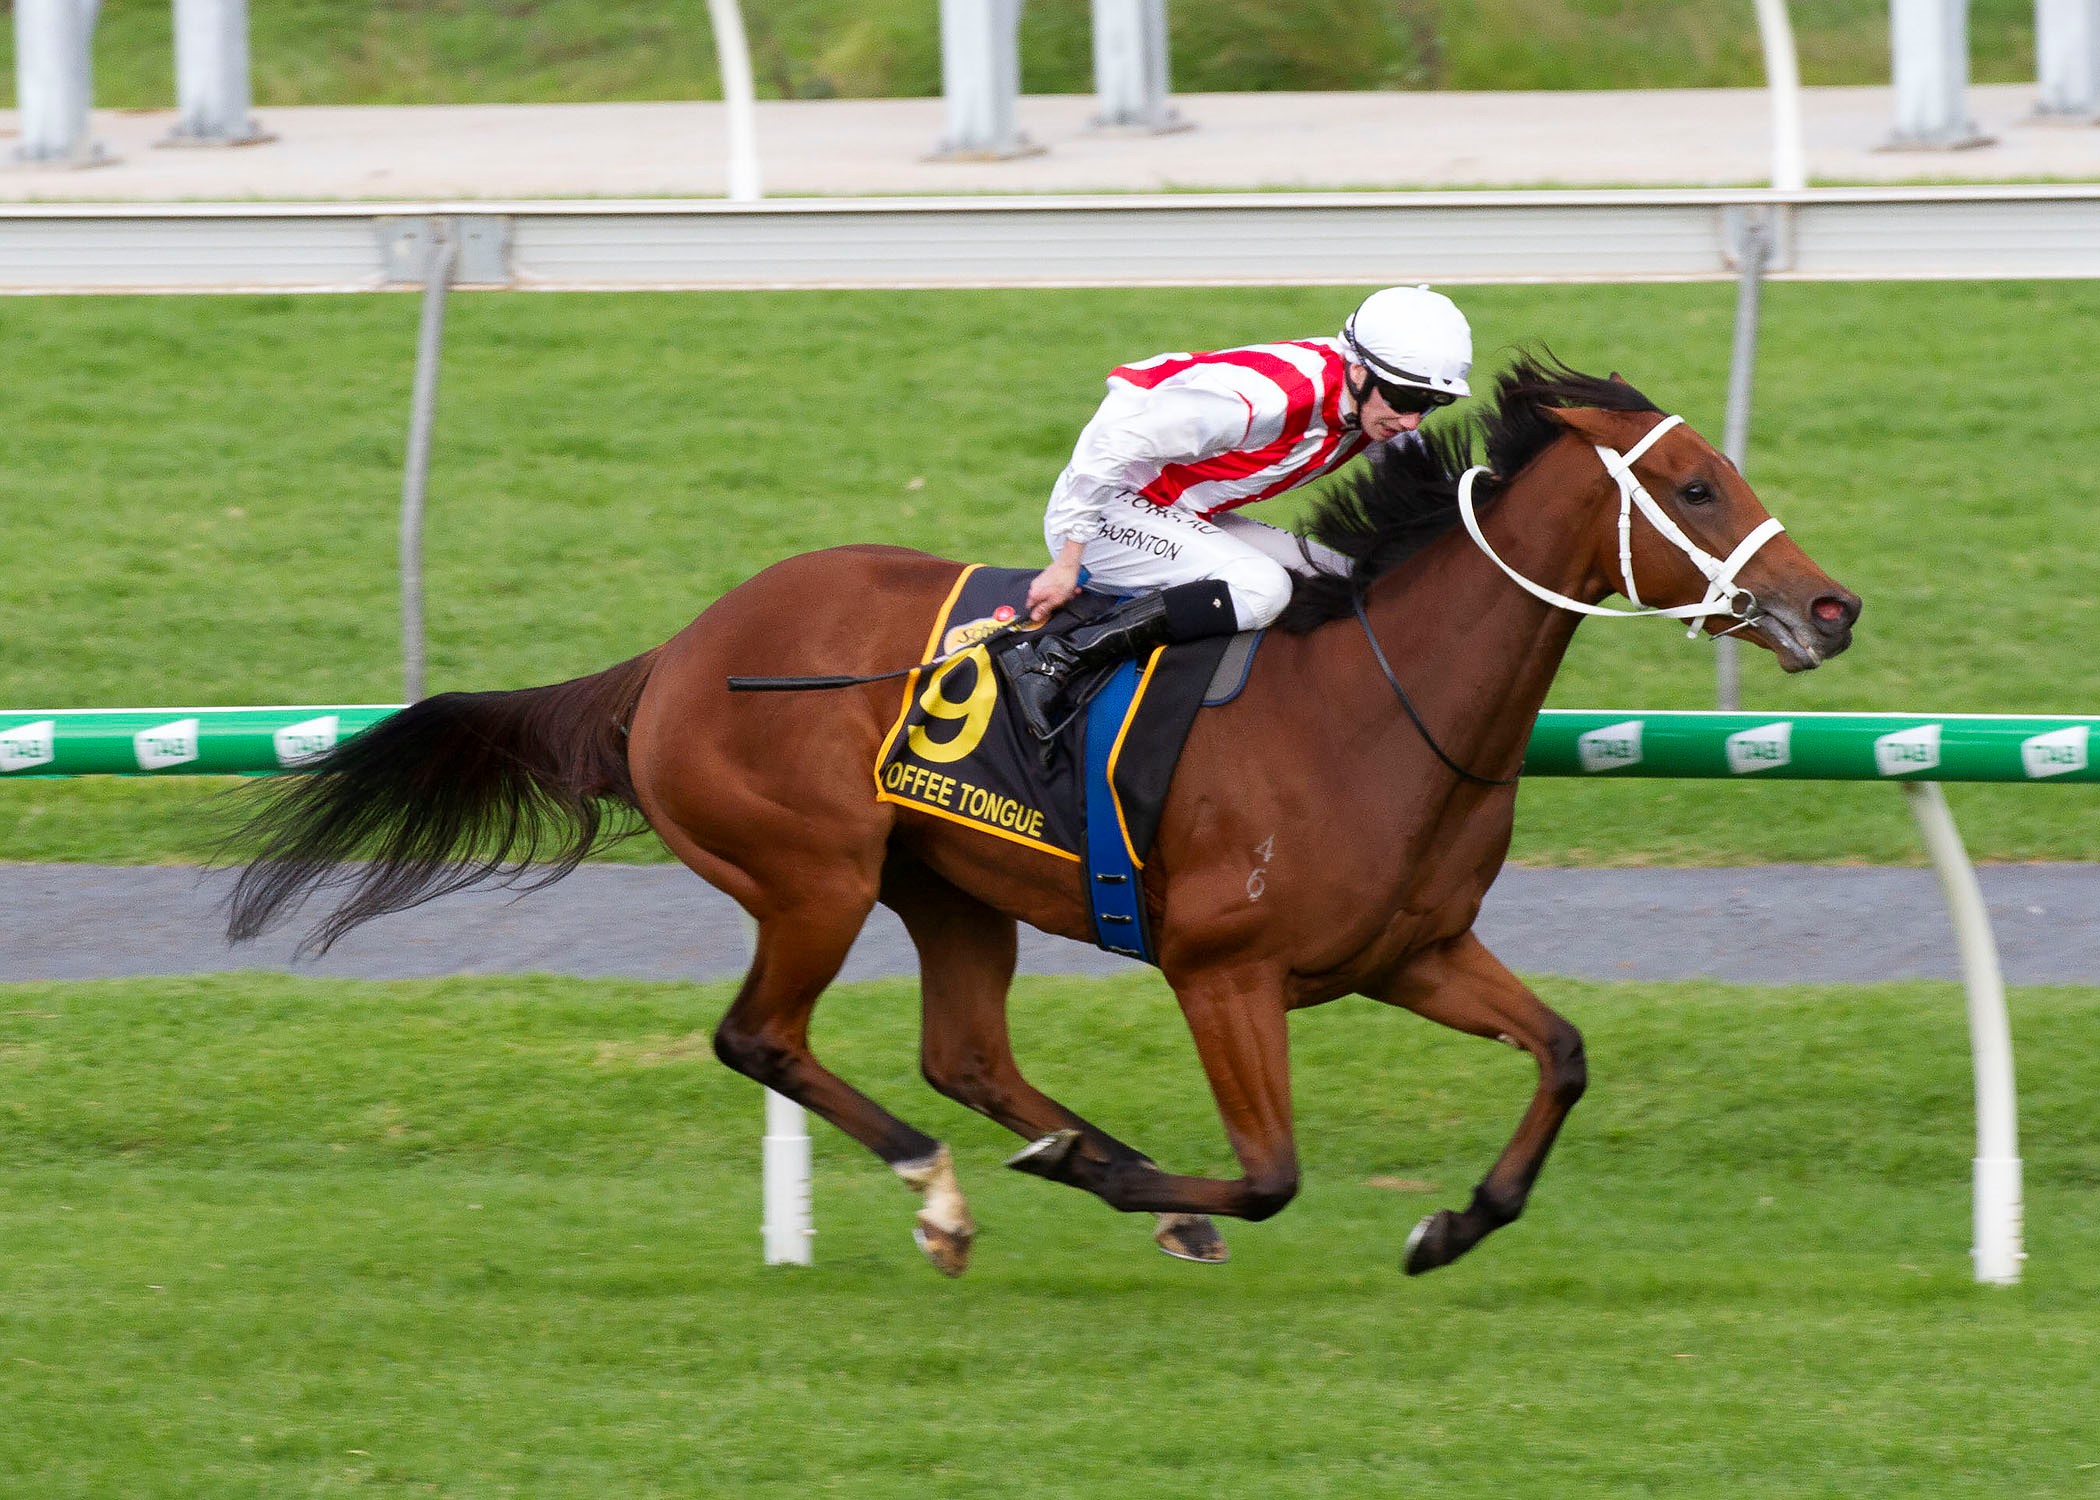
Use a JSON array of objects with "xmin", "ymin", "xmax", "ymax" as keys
[{"xmin": 1046, "ymin": 494, "xmax": 1348, "ymax": 630}]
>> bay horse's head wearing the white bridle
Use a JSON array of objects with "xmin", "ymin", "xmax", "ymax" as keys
[{"xmin": 1546, "ymin": 408, "xmax": 1861, "ymax": 672}]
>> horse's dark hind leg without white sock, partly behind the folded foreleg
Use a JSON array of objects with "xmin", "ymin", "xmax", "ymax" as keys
[{"xmin": 882, "ymin": 855, "xmax": 1229, "ymax": 1265}]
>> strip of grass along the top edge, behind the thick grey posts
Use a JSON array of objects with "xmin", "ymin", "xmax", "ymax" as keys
[{"xmin": 0, "ymin": 0, "xmax": 2035, "ymax": 107}]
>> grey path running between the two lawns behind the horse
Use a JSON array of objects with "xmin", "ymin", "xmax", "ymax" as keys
[{"xmin": 0, "ymin": 863, "xmax": 2100, "ymax": 985}]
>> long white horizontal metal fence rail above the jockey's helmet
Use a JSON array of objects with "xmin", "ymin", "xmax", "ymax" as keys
[{"xmin": 0, "ymin": 183, "xmax": 2100, "ymax": 294}]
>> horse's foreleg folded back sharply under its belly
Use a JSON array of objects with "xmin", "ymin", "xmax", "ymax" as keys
[{"xmin": 1012, "ymin": 968, "xmax": 1298, "ymax": 1221}]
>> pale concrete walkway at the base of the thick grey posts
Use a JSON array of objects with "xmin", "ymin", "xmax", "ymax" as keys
[{"xmin": 0, "ymin": 84, "xmax": 2100, "ymax": 202}]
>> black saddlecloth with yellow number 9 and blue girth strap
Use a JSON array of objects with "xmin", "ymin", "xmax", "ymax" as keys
[{"xmin": 876, "ymin": 567, "xmax": 1260, "ymax": 962}]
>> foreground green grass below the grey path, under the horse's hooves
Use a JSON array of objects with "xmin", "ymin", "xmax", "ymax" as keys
[{"xmin": 0, "ymin": 975, "xmax": 2100, "ymax": 1500}]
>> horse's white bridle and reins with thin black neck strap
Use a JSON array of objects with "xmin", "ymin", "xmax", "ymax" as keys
[{"xmin": 1348, "ymin": 416, "xmax": 1787, "ymax": 786}]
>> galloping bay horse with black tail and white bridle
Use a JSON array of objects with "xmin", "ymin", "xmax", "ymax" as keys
[{"xmin": 229, "ymin": 355, "xmax": 1861, "ymax": 1275}]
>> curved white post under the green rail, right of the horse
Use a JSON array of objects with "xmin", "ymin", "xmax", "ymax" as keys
[{"xmin": 1903, "ymin": 782, "xmax": 2027, "ymax": 1286}]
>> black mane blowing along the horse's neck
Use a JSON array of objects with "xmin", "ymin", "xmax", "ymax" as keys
[{"xmin": 1277, "ymin": 353, "xmax": 1661, "ymax": 632}]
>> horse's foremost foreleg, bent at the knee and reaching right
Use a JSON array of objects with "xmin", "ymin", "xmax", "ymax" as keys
[{"xmin": 1365, "ymin": 933, "xmax": 1590, "ymax": 1275}]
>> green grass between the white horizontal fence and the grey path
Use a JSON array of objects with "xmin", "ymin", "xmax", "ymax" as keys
[{"xmin": 0, "ymin": 282, "xmax": 2100, "ymax": 863}]
